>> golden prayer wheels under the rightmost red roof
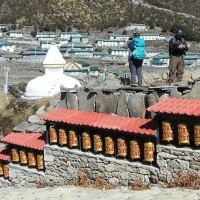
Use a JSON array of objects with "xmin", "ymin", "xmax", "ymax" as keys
[{"xmin": 162, "ymin": 122, "xmax": 200, "ymax": 146}]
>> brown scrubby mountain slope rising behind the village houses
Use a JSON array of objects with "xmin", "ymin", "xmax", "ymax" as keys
[{"xmin": 0, "ymin": 0, "xmax": 200, "ymax": 42}]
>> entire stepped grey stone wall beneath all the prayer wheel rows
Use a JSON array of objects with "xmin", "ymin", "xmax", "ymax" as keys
[{"xmin": 0, "ymin": 145, "xmax": 200, "ymax": 188}]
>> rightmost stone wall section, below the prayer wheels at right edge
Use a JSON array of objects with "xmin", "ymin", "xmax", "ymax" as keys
[{"xmin": 157, "ymin": 145, "xmax": 200, "ymax": 183}]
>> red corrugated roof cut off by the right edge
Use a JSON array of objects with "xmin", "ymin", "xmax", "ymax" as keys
[{"xmin": 147, "ymin": 97, "xmax": 200, "ymax": 117}]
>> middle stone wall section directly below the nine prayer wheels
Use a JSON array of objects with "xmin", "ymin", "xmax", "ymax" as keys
[{"xmin": 45, "ymin": 145, "xmax": 159, "ymax": 186}]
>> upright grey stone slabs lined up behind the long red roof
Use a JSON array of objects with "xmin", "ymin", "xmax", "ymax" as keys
[{"xmin": 60, "ymin": 88, "xmax": 159, "ymax": 118}]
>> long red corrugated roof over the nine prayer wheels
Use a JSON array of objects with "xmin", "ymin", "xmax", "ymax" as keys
[{"xmin": 42, "ymin": 108, "xmax": 157, "ymax": 135}]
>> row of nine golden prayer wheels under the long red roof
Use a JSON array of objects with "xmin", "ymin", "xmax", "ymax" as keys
[{"xmin": 49, "ymin": 128, "xmax": 155, "ymax": 162}]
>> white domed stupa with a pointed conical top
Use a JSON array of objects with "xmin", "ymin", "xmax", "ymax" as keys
[{"xmin": 23, "ymin": 43, "xmax": 81, "ymax": 99}]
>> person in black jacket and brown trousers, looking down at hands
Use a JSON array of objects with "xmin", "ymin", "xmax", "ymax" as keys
[{"xmin": 168, "ymin": 29, "xmax": 188, "ymax": 84}]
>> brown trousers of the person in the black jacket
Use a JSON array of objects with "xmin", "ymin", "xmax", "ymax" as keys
[{"xmin": 169, "ymin": 56, "xmax": 184, "ymax": 82}]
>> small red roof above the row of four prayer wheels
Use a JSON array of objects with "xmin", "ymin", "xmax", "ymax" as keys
[{"xmin": 0, "ymin": 132, "xmax": 45, "ymax": 150}]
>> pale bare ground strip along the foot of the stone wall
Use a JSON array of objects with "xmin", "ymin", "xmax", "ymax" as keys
[{"xmin": 0, "ymin": 186, "xmax": 200, "ymax": 200}]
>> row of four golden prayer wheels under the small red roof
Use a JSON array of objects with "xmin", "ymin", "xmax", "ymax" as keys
[{"xmin": 11, "ymin": 148, "xmax": 44, "ymax": 171}]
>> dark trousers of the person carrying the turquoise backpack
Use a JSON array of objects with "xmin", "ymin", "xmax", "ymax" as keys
[{"xmin": 129, "ymin": 59, "xmax": 143, "ymax": 85}]
